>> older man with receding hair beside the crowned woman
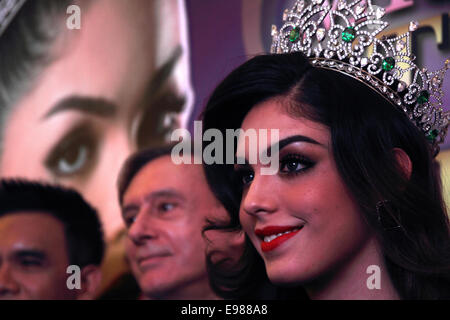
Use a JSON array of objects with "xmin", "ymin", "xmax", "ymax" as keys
[{"xmin": 118, "ymin": 146, "xmax": 242, "ymax": 300}]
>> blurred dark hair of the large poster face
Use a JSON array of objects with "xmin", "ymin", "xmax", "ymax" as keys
[{"xmin": 0, "ymin": 0, "xmax": 72, "ymax": 148}]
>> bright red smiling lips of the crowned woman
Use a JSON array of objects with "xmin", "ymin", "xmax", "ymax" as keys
[{"xmin": 255, "ymin": 226, "xmax": 303, "ymax": 252}]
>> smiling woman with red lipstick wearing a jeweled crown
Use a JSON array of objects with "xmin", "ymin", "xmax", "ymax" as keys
[{"xmin": 203, "ymin": 0, "xmax": 450, "ymax": 299}]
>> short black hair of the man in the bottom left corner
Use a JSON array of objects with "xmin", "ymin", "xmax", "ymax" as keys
[{"xmin": 0, "ymin": 179, "xmax": 105, "ymax": 268}]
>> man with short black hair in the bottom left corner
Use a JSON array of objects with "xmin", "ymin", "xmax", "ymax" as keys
[{"xmin": 0, "ymin": 180, "xmax": 104, "ymax": 300}]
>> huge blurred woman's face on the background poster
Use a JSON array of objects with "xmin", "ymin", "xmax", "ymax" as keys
[{"xmin": 0, "ymin": 0, "xmax": 191, "ymax": 239}]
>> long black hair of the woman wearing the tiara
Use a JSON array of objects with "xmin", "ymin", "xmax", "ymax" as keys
[{"xmin": 202, "ymin": 53, "xmax": 450, "ymax": 299}]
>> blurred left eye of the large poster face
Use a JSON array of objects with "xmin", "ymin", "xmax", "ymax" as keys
[{"xmin": 45, "ymin": 125, "xmax": 97, "ymax": 177}]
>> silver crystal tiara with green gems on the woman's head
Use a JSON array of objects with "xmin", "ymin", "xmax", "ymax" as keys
[{"xmin": 271, "ymin": 0, "xmax": 450, "ymax": 156}]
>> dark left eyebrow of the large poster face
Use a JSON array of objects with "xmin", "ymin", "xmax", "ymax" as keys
[{"xmin": 42, "ymin": 95, "xmax": 118, "ymax": 120}]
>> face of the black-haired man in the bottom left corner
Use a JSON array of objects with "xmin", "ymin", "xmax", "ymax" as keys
[{"xmin": 0, "ymin": 212, "xmax": 76, "ymax": 300}]
